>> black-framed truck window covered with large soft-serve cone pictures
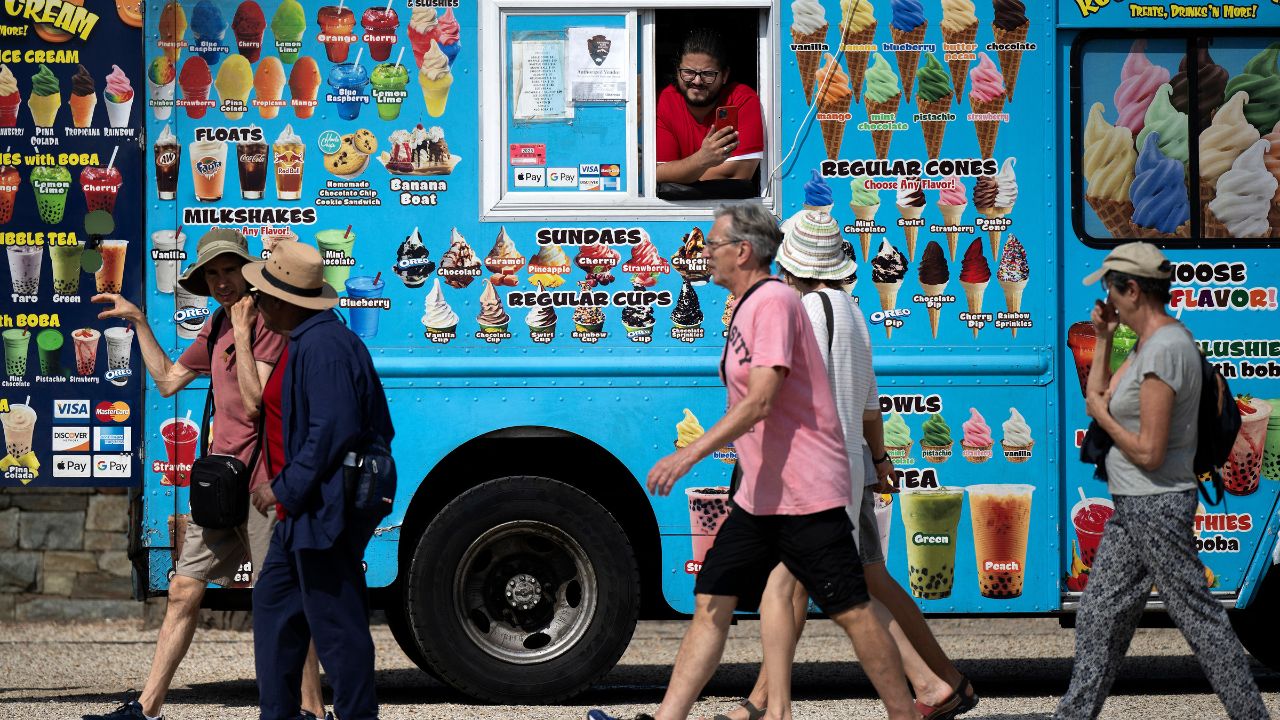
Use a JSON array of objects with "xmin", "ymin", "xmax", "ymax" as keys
[{"xmin": 1071, "ymin": 33, "xmax": 1280, "ymax": 246}]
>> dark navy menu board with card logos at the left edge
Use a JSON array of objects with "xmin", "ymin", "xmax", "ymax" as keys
[{"xmin": 0, "ymin": 0, "xmax": 145, "ymax": 487}]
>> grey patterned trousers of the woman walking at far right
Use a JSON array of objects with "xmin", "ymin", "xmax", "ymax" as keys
[{"xmin": 1055, "ymin": 489, "xmax": 1270, "ymax": 720}]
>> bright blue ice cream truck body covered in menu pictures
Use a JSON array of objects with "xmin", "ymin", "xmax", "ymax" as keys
[{"xmin": 125, "ymin": 0, "xmax": 1280, "ymax": 612}]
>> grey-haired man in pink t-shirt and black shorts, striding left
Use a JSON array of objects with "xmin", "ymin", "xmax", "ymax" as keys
[{"xmin": 589, "ymin": 202, "xmax": 920, "ymax": 720}]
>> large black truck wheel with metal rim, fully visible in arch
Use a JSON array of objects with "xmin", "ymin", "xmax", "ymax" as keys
[{"xmin": 406, "ymin": 477, "xmax": 640, "ymax": 705}]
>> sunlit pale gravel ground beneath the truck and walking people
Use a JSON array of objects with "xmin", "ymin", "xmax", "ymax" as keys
[{"xmin": 0, "ymin": 619, "xmax": 1280, "ymax": 720}]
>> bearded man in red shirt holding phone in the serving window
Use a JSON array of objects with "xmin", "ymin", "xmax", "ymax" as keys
[{"xmin": 657, "ymin": 29, "xmax": 764, "ymax": 196}]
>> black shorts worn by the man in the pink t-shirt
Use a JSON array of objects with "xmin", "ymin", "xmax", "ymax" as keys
[{"xmin": 694, "ymin": 507, "xmax": 870, "ymax": 616}]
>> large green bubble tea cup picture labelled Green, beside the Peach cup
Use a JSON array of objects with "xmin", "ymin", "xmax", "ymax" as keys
[{"xmin": 899, "ymin": 487, "xmax": 964, "ymax": 600}]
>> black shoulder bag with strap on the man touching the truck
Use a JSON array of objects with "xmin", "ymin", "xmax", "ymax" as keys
[{"xmin": 191, "ymin": 309, "xmax": 262, "ymax": 529}]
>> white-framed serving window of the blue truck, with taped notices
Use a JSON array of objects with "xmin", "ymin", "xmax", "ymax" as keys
[{"xmin": 479, "ymin": 0, "xmax": 778, "ymax": 220}]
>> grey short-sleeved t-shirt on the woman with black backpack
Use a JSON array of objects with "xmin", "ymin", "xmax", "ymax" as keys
[{"xmin": 1107, "ymin": 323, "xmax": 1201, "ymax": 495}]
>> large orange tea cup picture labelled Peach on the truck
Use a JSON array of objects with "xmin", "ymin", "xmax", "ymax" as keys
[{"xmin": 965, "ymin": 484, "xmax": 1036, "ymax": 600}]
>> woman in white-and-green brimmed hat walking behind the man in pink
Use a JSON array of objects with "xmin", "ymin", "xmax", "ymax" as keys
[{"xmin": 718, "ymin": 210, "xmax": 978, "ymax": 720}]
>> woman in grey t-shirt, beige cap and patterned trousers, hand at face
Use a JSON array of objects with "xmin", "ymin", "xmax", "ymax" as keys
[{"xmin": 1055, "ymin": 242, "xmax": 1267, "ymax": 720}]
